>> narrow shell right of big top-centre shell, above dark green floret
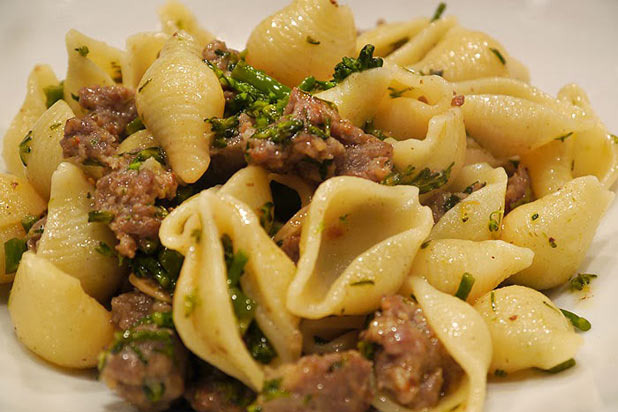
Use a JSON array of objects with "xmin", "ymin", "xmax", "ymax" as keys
[{"xmin": 356, "ymin": 18, "xmax": 429, "ymax": 57}]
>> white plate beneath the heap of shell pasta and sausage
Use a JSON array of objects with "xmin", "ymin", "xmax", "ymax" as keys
[{"xmin": 0, "ymin": 0, "xmax": 618, "ymax": 412}]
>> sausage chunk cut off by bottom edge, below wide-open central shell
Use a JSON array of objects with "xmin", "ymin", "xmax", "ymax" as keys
[{"xmin": 258, "ymin": 351, "xmax": 373, "ymax": 412}]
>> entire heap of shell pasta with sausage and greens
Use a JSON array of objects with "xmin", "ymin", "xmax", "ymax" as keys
[{"xmin": 0, "ymin": 0, "xmax": 618, "ymax": 412}]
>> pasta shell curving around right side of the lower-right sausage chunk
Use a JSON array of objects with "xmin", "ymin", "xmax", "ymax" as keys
[{"xmin": 373, "ymin": 277, "xmax": 492, "ymax": 412}]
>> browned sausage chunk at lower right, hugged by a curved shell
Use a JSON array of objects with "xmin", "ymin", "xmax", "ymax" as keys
[{"xmin": 360, "ymin": 295, "xmax": 462, "ymax": 409}]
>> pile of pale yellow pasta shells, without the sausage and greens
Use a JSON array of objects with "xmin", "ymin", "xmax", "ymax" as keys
[{"xmin": 0, "ymin": 0, "xmax": 618, "ymax": 411}]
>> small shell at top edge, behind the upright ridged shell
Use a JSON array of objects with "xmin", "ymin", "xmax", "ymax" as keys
[{"xmin": 159, "ymin": 0, "xmax": 215, "ymax": 48}]
